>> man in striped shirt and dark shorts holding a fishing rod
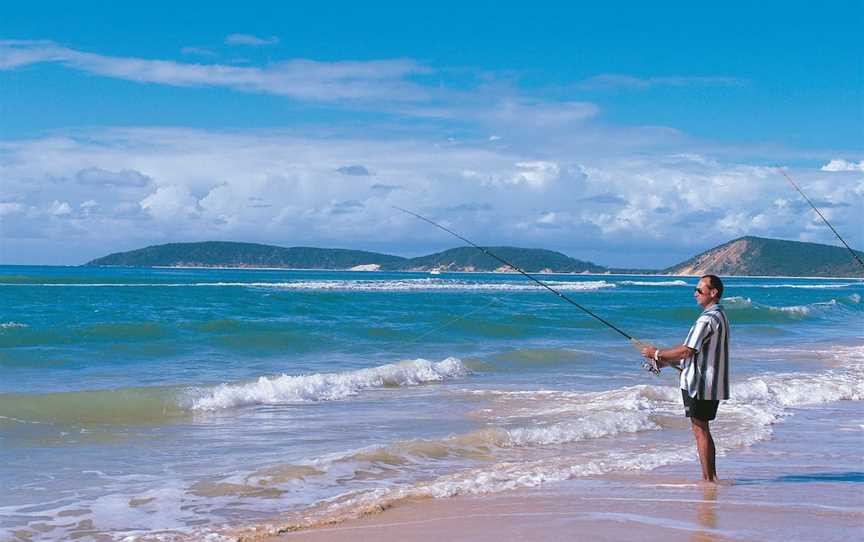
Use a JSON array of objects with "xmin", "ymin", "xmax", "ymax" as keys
[{"xmin": 642, "ymin": 275, "xmax": 729, "ymax": 482}]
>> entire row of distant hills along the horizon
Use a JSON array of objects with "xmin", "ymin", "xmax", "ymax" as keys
[{"xmin": 85, "ymin": 237, "xmax": 864, "ymax": 277}]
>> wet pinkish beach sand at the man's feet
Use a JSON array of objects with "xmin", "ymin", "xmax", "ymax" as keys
[{"xmin": 240, "ymin": 402, "xmax": 864, "ymax": 542}]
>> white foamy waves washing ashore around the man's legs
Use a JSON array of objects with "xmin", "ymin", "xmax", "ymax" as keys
[{"xmin": 235, "ymin": 347, "xmax": 864, "ymax": 540}]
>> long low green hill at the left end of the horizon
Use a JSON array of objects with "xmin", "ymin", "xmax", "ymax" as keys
[{"xmin": 85, "ymin": 241, "xmax": 405, "ymax": 269}]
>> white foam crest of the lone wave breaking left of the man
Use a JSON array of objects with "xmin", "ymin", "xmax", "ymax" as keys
[{"xmin": 189, "ymin": 357, "xmax": 468, "ymax": 410}]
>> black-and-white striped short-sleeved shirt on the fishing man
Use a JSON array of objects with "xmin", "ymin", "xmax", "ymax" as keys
[{"xmin": 681, "ymin": 304, "xmax": 729, "ymax": 401}]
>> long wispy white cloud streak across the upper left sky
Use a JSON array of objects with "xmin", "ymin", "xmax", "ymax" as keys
[{"xmin": 0, "ymin": 40, "xmax": 608, "ymax": 136}]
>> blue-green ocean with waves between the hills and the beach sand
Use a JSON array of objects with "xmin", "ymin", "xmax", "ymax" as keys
[{"xmin": 0, "ymin": 266, "xmax": 864, "ymax": 541}]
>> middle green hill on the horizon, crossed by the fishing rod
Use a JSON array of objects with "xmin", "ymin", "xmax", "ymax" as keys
[{"xmin": 402, "ymin": 247, "xmax": 607, "ymax": 273}]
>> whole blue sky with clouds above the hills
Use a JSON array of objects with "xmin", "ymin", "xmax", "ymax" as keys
[{"xmin": 0, "ymin": 0, "xmax": 864, "ymax": 268}]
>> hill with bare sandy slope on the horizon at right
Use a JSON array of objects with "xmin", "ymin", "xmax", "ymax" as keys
[{"xmin": 661, "ymin": 236, "xmax": 864, "ymax": 277}]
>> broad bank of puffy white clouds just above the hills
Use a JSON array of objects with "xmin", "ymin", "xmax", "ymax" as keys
[{"xmin": 0, "ymin": 125, "xmax": 864, "ymax": 266}]
